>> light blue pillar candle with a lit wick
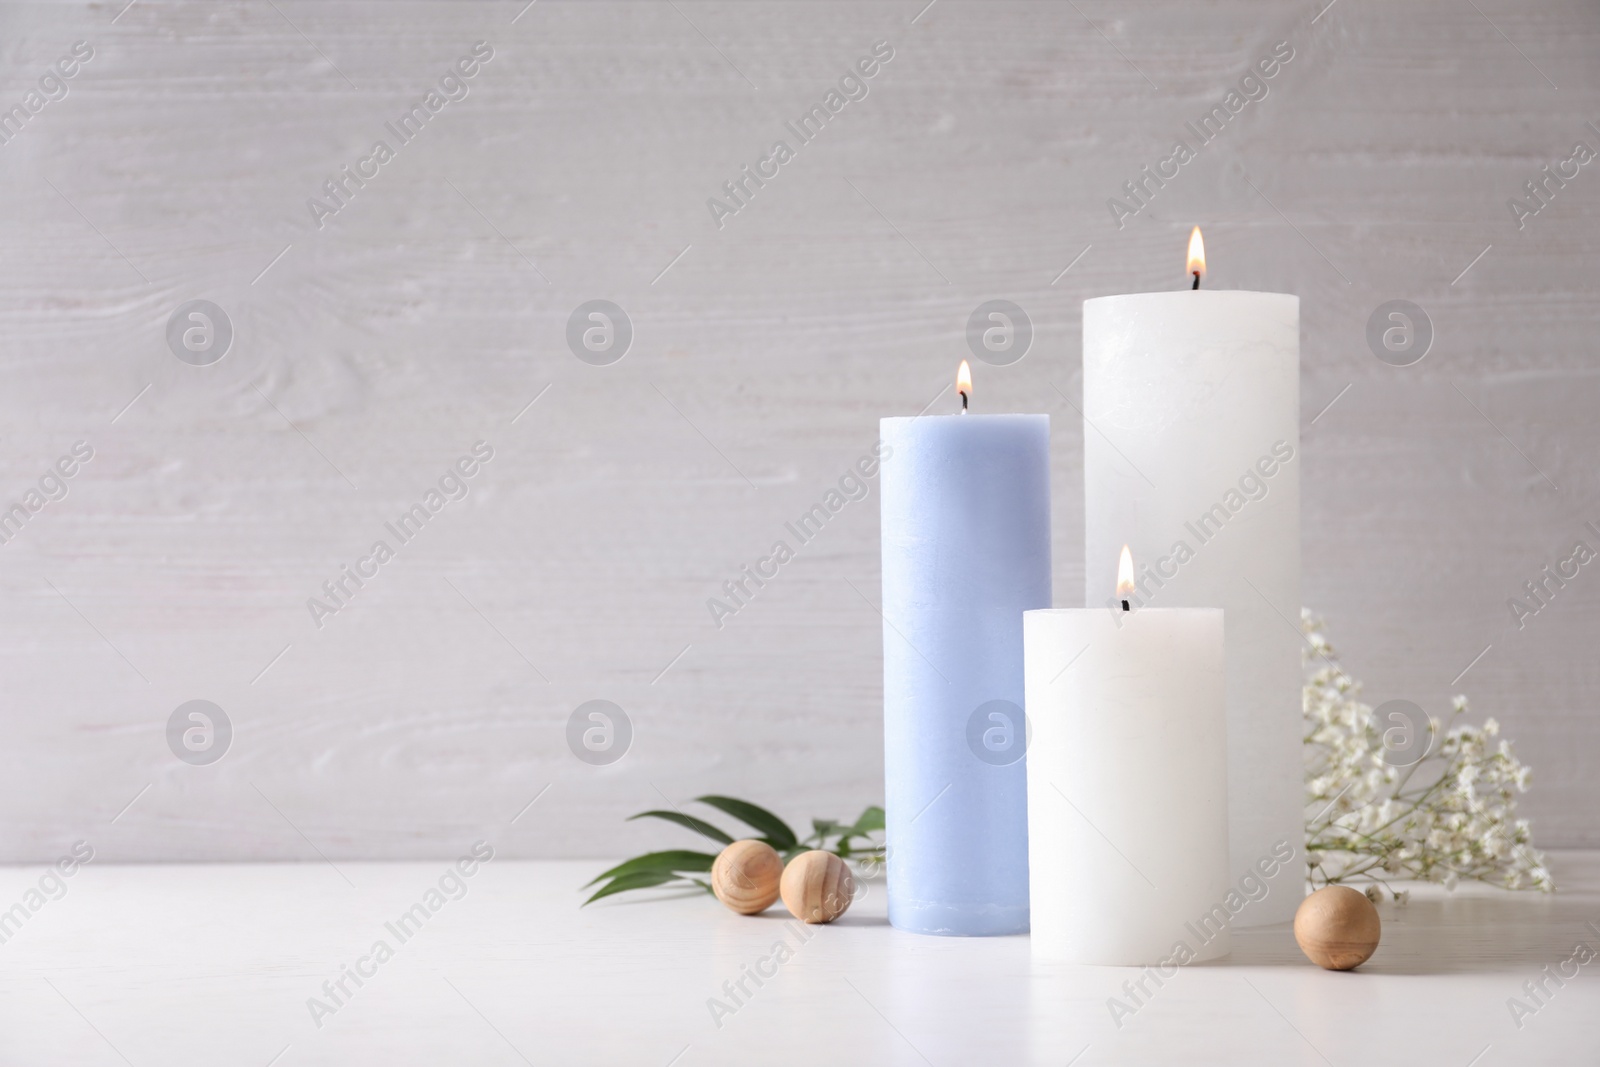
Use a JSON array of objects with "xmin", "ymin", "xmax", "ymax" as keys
[{"xmin": 878, "ymin": 413, "xmax": 1051, "ymax": 936}]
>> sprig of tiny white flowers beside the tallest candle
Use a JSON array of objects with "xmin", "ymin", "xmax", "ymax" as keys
[{"xmin": 1301, "ymin": 609, "xmax": 1555, "ymax": 904}]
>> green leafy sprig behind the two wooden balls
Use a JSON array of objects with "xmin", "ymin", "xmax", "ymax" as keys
[{"xmin": 584, "ymin": 797, "xmax": 885, "ymax": 904}]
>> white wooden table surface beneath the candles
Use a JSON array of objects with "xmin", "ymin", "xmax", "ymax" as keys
[{"xmin": 0, "ymin": 851, "xmax": 1600, "ymax": 1067}]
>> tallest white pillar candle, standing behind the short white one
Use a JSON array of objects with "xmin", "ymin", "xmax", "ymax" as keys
[{"xmin": 1083, "ymin": 290, "xmax": 1304, "ymax": 925}]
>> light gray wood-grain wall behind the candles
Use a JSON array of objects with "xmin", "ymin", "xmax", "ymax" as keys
[{"xmin": 0, "ymin": 0, "xmax": 1600, "ymax": 861}]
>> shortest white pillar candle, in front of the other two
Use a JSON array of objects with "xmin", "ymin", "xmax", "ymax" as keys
[{"xmin": 1022, "ymin": 608, "xmax": 1232, "ymax": 966}]
